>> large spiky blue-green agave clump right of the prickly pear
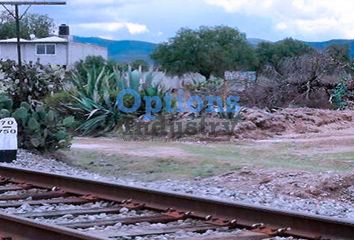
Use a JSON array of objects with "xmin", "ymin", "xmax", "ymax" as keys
[{"xmin": 68, "ymin": 67, "xmax": 164, "ymax": 135}]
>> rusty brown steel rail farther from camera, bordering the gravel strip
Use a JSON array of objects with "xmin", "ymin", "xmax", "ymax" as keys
[{"xmin": 0, "ymin": 166, "xmax": 354, "ymax": 240}]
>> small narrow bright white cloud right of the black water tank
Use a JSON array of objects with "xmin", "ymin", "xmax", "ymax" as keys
[{"xmin": 75, "ymin": 22, "xmax": 149, "ymax": 35}]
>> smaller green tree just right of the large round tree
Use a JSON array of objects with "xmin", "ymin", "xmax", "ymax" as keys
[{"xmin": 256, "ymin": 38, "xmax": 315, "ymax": 68}]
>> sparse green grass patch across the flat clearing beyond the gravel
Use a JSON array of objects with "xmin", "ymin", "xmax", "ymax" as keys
[{"xmin": 63, "ymin": 138, "xmax": 354, "ymax": 181}]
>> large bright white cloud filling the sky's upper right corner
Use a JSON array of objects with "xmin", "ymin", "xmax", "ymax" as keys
[{"xmin": 204, "ymin": 0, "xmax": 354, "ymax": 39}]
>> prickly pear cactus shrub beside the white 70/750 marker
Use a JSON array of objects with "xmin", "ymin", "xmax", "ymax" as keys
[{"xmin": 0, "ymin": 61, "xmax": 75, "ymax": 152}]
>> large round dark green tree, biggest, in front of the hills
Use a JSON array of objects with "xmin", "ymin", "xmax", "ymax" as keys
[{"xmin": 151, "ymin": 26, "xmax": 257, "ymax": 78}]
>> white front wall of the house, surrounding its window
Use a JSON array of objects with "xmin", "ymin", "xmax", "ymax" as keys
[{"xmin": 0, "ymin": 43, "xmax": 67, "ymax": 65}]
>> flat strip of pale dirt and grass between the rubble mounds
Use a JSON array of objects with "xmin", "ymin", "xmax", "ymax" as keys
[{"xmin": 63, "ymin": 128, "xmax": 354, "ymax": 181}]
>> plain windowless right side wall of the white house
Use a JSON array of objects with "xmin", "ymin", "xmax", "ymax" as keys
[{"xmin": 69, "ymin": 42, "xmax": 108, "ymax": 65}]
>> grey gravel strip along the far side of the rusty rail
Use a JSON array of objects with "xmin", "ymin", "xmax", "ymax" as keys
[{"xmin": 3, "ymin": 150, "xmax": 354, "ymax": 221}]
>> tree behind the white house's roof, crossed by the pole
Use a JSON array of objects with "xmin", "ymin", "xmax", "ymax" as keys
[{"xmin": 0, "ymin": 12, "xmax": 55, "ymax": 39}]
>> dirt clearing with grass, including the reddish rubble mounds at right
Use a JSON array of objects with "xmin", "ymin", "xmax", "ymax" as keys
[{"xmin": 59, "ymin": 109, "xmax": 354, "ymax": 202}]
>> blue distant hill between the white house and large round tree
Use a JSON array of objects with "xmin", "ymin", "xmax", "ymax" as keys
[{"xmin": 74, "ymin": 36, "xmax": 157, "ymax": 62}]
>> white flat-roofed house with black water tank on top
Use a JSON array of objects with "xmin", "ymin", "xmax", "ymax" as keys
[{"xmin": 0, "ymin": 25, "xmax": 108, "ymax": 68}]
